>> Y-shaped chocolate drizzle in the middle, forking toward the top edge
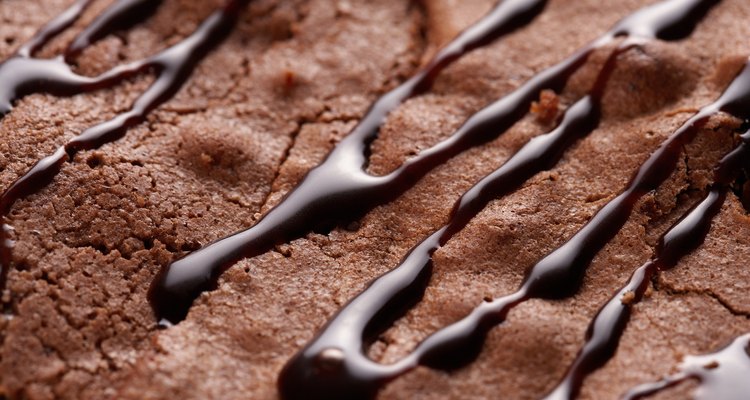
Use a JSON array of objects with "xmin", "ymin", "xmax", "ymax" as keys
[{"xmin": 150, "ymin": 0, "xmax": 719, "ymax": 323}]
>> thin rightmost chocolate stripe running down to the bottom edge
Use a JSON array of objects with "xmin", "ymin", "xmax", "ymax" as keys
[{"xmin": 545, "ymin": 132, "xmax": 750, "ymax": 400}]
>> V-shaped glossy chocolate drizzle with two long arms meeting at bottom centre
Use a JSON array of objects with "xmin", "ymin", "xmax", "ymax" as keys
[{"xmin": 279, "ymin": 1, "xmax": 729, "ymax": 398}]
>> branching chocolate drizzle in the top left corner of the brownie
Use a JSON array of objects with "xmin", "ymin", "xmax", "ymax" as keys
[{"xmin": 0, "ymin": 0, "xmax": 247, "ymax": 289}]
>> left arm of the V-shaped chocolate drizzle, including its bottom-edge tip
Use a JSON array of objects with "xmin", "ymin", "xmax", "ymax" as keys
[{"xmin": 279, "ymin": 42, "xmax": 619, "ymax": 399}]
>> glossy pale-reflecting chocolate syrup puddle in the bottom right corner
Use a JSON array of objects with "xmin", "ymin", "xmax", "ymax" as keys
[{"xmin": 623, "ymin": 334, "xmax": 750, "ymax": 400}]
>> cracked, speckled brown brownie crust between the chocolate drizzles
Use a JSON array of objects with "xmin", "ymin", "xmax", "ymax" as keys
[{"xmin": 0, "ymin": 0, "xmax": 750, "ymax": 399}]
